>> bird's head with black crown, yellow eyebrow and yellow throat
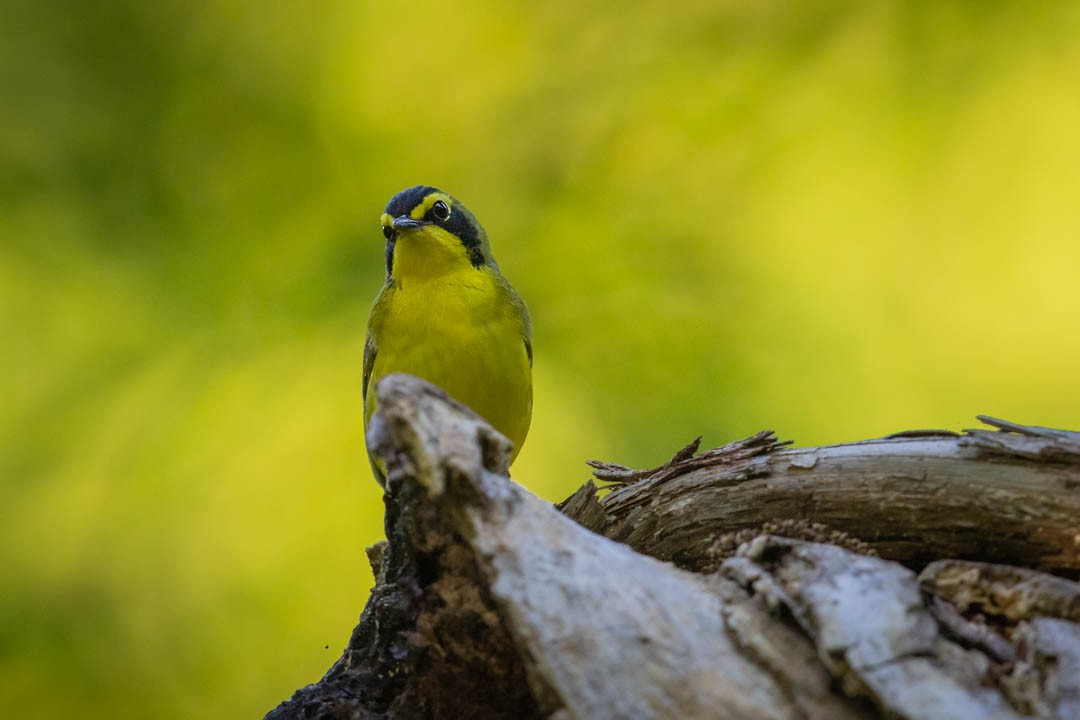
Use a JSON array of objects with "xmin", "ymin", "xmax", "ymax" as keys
[{"xmin": 380, "ymin": 185, "xmax": 498, "ymax": 279}]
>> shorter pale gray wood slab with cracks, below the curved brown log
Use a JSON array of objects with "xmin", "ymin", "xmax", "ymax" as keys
[{"xmin": 723, "ymin": 535, "xmax": 1020, "ymax": 720}]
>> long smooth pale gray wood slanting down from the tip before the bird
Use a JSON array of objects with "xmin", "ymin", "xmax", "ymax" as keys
[{"xmin": 374, "ymin": 376, "xmax": 825, "ymax": 720}]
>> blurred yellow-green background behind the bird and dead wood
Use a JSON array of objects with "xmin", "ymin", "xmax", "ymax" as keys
[{"xmin": 0, "ymin": 0, "xmax": 1080, "ymax": 719}]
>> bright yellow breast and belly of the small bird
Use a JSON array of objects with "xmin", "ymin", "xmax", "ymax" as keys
[{"xmin": 365, "ymin": 273, "xmax": 532, "ymax": 458}]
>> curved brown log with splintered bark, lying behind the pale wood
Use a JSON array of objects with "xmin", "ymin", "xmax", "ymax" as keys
[{"xmin": 564, "ymin": 418, "xmax": 1080, "ymax": 578}]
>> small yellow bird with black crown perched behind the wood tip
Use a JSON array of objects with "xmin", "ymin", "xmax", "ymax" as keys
[{"xmin": 363, "ymin": 185, "xmax": 532, "ymax": 487}]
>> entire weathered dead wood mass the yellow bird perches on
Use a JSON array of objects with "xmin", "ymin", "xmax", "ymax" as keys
[{"xmin": 267, "ymin": 376, "xmax": 1080, "ymax": 720}]
